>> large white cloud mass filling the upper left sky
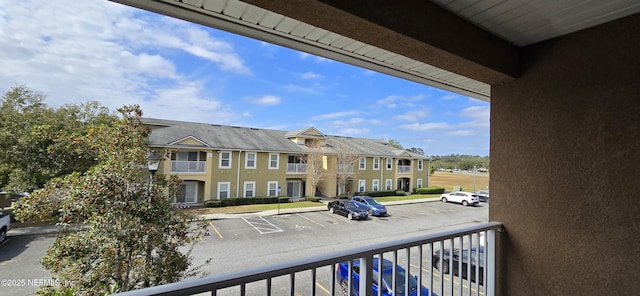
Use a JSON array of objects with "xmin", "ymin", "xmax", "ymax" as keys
[{"xmin": 0, "ymin": 0, "xmax": 250, "ymax": 112}]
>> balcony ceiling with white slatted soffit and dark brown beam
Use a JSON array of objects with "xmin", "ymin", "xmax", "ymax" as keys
[{"xmin": 112, "ymin": 0, "xmax": 640, "ymax": 101}]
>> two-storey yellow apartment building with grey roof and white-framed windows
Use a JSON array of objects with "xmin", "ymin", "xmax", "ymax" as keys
[{"xmin": 142, "ymin": 118, "xmax": 429, "ymax": 204}]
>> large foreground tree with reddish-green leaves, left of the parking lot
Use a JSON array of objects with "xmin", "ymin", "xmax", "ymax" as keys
[{"xmin": 16, "ymin": 106, "xmax": 206, "ymax": 295}]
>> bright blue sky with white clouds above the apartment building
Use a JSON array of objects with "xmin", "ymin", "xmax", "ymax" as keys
[{"xmin": 0, "ymin": 0, "xmax": 489, "ymax": 156}]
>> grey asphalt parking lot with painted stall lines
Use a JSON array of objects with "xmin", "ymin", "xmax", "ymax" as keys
[{"xmin": 0, "ymin": 201, "xmax": 488, "ymax": 295}]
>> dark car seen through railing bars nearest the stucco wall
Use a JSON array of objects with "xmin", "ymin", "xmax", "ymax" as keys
[{"xmin": 432, "ymin": 246, "xmax": 485, "ymax": 285}]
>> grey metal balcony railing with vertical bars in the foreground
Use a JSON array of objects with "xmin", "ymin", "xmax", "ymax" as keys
[{"xmin": 120, "ymin": 222, "xmax": 502, "ymax": 296}]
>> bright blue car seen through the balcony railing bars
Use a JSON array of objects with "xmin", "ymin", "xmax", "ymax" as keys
[{"xmin": 336, "ymin": 258, "xmax": 437, "ymax": 296}]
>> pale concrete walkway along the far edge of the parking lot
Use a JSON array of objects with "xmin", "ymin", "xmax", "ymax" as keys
[{"xmin": 7, "ymin": 197, "xmax": 440, "ymax": 237}]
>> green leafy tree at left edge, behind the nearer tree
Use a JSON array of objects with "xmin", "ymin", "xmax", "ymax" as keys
[{"xmin": 0, "ymin": 86, "xmax": 117, "ymax": 192}]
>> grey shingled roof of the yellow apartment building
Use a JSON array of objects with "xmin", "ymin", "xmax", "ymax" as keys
[{"xmin": 141, "ymin": 118, "xmax": 426, "ymax": 158}]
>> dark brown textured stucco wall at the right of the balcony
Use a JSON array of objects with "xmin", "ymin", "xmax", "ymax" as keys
[{"xmin": 490, "ymin": 15, "xmax": 640, "ymax": 295}]
